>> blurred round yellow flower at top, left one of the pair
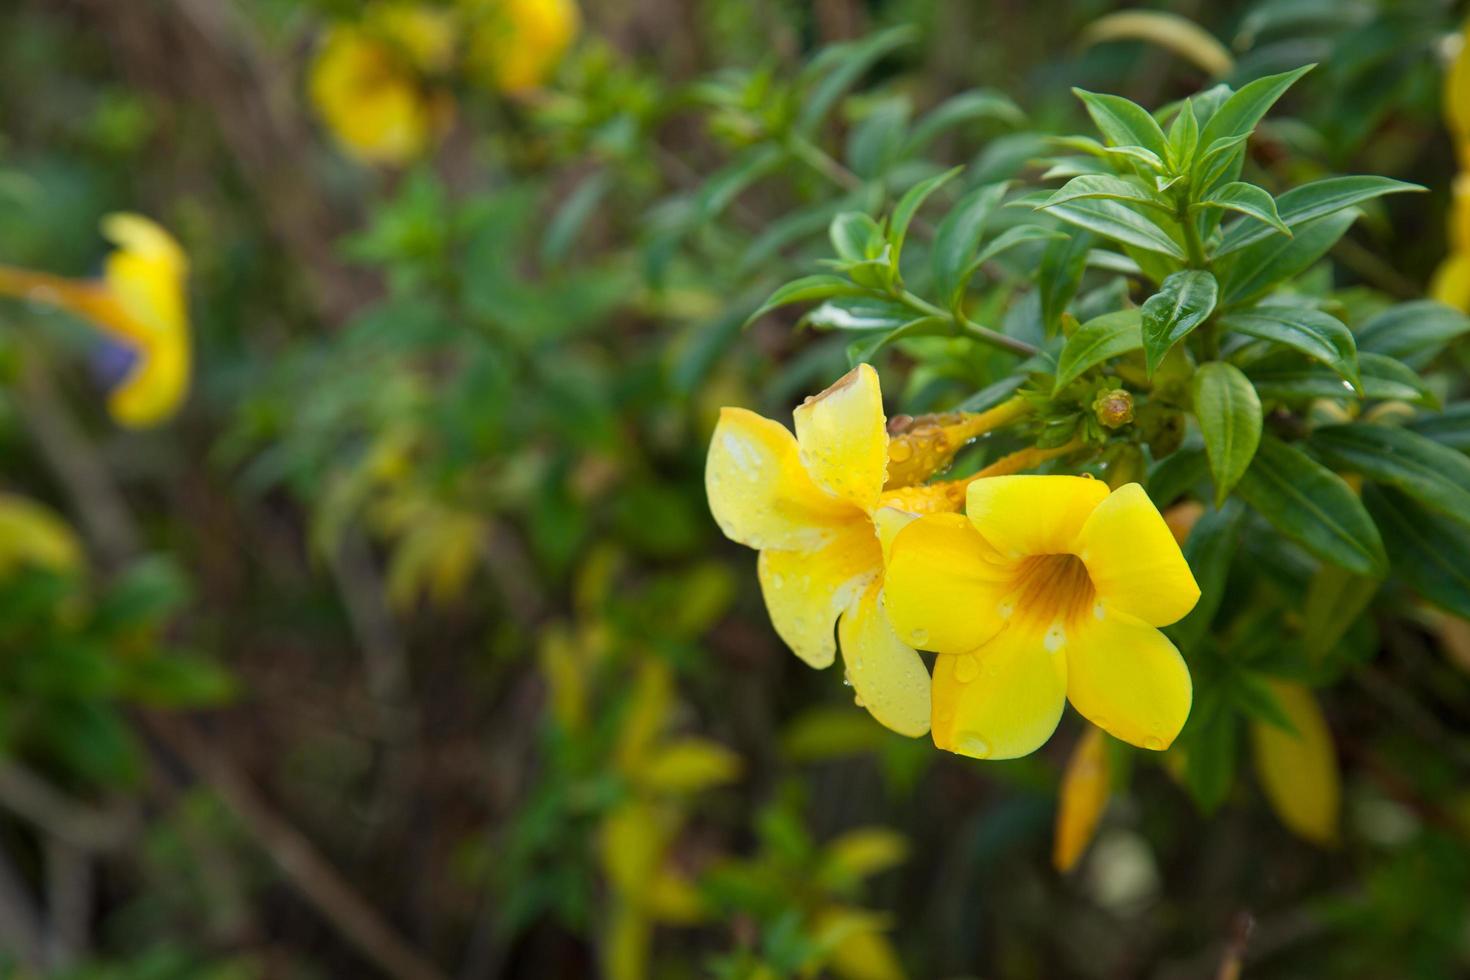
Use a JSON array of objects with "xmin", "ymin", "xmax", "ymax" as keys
[{"xmin": 309, "ymin": 7, "xmax": 453, "ymax": 166}]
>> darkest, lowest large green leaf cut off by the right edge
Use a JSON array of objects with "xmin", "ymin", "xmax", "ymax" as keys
[{"xmin": 1363, "ymin": 486, "xmax": 1470, "ymax": 619}]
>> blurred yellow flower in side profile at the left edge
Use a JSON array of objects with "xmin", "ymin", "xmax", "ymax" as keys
[{"xmin": 0, "ymin": 215, "xmax": 191, "ymax": 428}]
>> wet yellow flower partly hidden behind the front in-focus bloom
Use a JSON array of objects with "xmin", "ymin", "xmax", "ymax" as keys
[{"xmin": 704, "ymin": 364, "xmax": 958, "ymax": 736}]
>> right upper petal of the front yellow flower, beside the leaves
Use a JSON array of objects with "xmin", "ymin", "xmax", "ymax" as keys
[{"xmin": 1076, "ymin": 483, "xmax": 1200, "ymax": 626}]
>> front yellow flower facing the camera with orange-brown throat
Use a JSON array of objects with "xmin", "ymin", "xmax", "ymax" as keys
[{"xmin": 885, "ymin": 476, "xmax": 1200, "ymax": 758}]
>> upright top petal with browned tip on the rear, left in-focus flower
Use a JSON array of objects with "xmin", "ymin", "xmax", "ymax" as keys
[{"xmin": 795, "ymin": 364, "xmax": 888, "ymax": 513}]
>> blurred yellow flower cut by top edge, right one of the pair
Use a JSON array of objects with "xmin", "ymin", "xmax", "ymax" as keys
[{"xmin": 465, "ymin": 0, "xmax": 582, "ymax": 93}]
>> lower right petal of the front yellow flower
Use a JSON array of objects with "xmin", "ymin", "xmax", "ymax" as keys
[{"xmin": 1063, "ymin": 610, "xmax": 1194, "ymax": 751}]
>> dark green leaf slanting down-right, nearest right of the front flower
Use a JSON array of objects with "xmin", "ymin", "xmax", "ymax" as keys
[{"xmin": 1236, "ymin": 435, "xmax": 1386, "ymax": 576}]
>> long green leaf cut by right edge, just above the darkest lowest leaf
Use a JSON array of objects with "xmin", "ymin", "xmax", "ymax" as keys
[{"xmin": 1311, "ymin": 425, "xmax": 1470, "ymax": 528}]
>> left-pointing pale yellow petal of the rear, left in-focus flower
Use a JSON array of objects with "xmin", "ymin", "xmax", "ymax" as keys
[{"xmin": 704, "ymin": 408, "xmax": 867, "ymax": 550}]
